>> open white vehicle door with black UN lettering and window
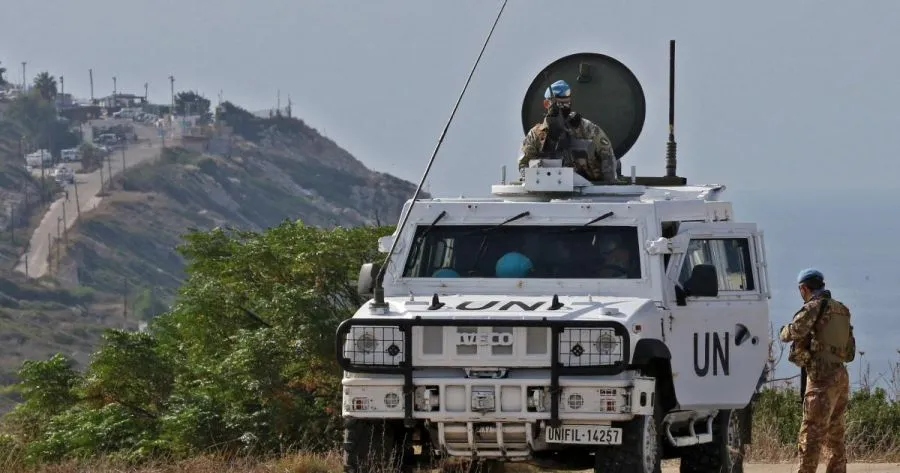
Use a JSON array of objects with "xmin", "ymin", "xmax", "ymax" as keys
[{"xmin": 667, "ymin": 222, "xmax": 769, "ymax": 409}]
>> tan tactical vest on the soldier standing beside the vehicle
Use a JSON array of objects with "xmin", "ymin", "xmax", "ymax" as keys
[{"xmin": 809, "ymin": 297, "xmax": 856, "ymax": 363}]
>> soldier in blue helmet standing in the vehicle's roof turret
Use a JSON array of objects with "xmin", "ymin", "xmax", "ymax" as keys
[{"xmin": 519, "ymin": 80, "xmax": 619, "ymax": 182}]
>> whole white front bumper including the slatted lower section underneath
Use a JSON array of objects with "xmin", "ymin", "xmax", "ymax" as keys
[{"xmin": 342, "ymin": 370, "xmax": 654, "ymax": 460}]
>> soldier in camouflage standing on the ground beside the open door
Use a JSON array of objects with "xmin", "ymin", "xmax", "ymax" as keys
[{"xmin": 780, "ymin": 269, "xmax": 856, "ymax": 473}]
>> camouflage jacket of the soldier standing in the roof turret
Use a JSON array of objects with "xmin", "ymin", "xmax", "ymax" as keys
[{"xmin": 519, "ymin": 116, "xmax": 618, "ymax": 182}]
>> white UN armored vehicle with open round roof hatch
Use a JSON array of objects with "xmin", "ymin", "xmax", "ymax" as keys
[{"xmin": 336, "ymin": 43, "xmax": 770, "ymax": 473}]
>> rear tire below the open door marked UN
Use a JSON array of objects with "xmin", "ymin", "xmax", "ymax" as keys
[{"xmin": 679, "ymin": 410, "xmax": 746, "ymax": 473}]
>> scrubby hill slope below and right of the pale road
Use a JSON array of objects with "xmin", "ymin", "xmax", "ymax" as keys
[{"xmin": 0, "ymin": 104, "xmax": 424, "ymax": 412}]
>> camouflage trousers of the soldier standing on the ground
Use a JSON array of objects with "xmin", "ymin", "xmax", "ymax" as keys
[{"xmin": 796, "ymin": 366, "xmax": 850, "ymax": 473}]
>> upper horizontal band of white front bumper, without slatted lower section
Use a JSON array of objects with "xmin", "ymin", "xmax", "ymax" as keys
[{"xmin": 342, "ymin": 370, "xmax": 654, "ymax": 423}]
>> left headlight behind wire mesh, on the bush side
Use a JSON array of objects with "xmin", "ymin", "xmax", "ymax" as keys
[{"xmin": 344, "ymin": 326, "xmax": 405, "ymax": 367}]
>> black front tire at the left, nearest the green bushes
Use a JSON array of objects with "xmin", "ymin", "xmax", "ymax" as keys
[{"xmin": 343, "ymin": 419, "xmax": 412, "ymax": 473}]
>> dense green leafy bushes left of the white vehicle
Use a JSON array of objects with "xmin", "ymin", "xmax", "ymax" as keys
[{"xmin": 0, "ymin": 220, "xmax": 393, "ymax": 462}]
